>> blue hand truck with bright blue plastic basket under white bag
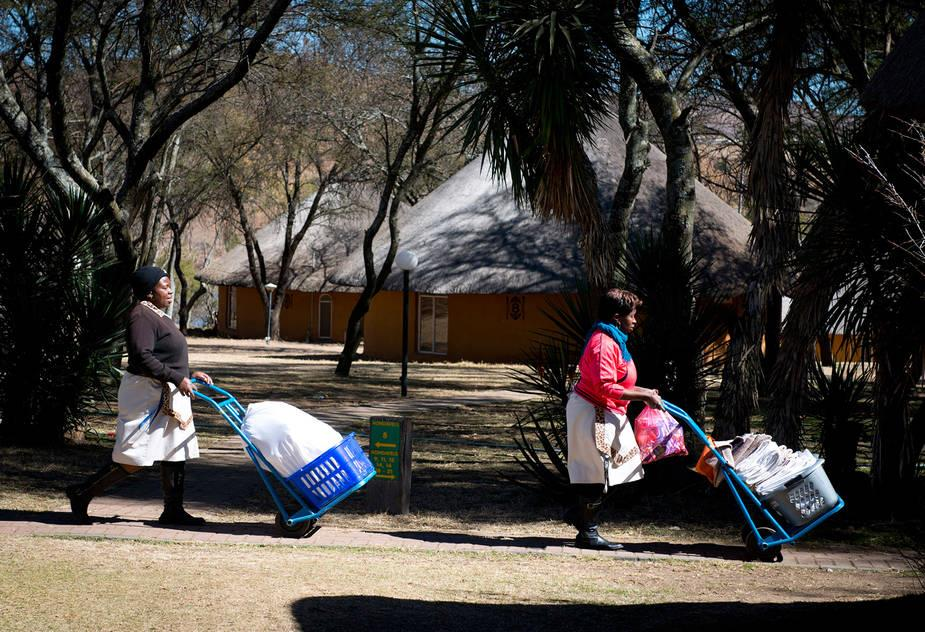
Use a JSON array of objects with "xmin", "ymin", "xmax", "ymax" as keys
[{"xmin": 193, "ymin": 379, "xmax": 376, "ymax": 538}]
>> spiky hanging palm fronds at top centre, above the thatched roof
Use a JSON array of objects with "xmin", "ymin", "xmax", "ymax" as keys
[{"xmin": 427, "ymin": 0, "xmax": 616, "ymax": 269}]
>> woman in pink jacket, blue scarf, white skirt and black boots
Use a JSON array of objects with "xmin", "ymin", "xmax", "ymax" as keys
[{"xmin": 565, "ymin": 289, "xmax": 662, "ymax": 551}]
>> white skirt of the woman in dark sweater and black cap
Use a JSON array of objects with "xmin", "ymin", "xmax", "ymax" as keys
[{"xmin": 112, "ymin": 372, "xmax": 199, "ymax": 466}]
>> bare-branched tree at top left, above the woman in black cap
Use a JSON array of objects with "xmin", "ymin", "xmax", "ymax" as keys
[{"xmin": 0, "ymin": 0, "xmax": 291, "ymax": 268}]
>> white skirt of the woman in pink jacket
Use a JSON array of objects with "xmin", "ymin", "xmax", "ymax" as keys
[{"xmin": 565, "ymin": 392, "xmax": 643, "ymax": 486}]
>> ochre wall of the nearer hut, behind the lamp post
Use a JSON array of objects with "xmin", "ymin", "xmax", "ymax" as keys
[{"xmin": 364, "ymin": 292, "xmax": 561, "ymax": 362}]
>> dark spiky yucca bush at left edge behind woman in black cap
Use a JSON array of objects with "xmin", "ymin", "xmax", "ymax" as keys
[{"xmin": 0, "ymin": 160, "xmax": 128, "ymax": 445}]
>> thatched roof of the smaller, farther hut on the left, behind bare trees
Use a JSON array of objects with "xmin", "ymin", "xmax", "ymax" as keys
[{"xmin": 196, "ymin": 186, "xmax": 374, "ymax": 292}]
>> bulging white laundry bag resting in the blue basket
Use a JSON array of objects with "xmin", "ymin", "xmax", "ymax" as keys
[{"xmin": 241, "ymin": 402, "xmax": 343, "ymax": 477}]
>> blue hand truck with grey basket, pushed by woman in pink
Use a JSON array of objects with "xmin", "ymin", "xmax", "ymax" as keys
[{"xmin": 662, "ymin": 400, "xmax": 845, "ymax": 562}]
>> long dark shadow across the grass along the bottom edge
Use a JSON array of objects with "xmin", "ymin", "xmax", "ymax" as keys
[{"xmin": 292, "ymin": 595, "xmax": 925, "ymax": 632}]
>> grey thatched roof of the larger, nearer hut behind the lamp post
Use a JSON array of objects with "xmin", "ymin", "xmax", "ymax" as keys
[{"xmin": 332, "ymin": 115, "xmax": 750, "ymax": 296}]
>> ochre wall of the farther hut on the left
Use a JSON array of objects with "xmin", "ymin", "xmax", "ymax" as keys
[{"xmin": 216, "ymin": 286, "xmax": 359, "ymax": 342}]
